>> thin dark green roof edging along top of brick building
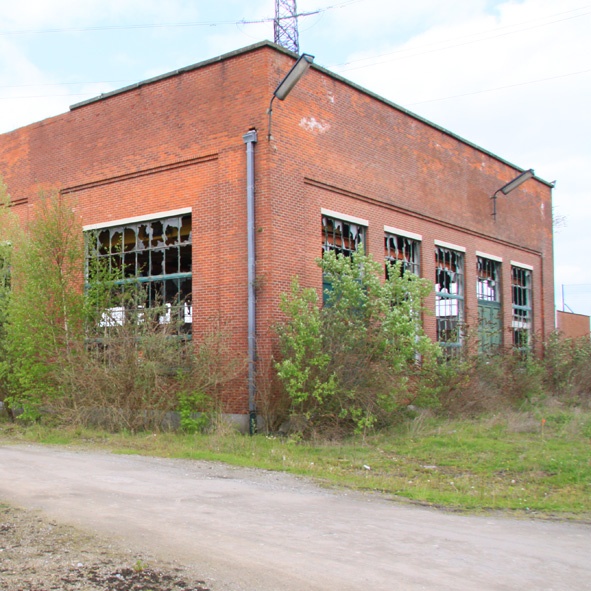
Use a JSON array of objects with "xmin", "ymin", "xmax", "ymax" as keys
[{"xmin": 70, "ymin": 40, "xmax": 554, "ymax": 187}]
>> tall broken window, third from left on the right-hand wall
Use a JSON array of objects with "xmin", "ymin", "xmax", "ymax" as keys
[{"xmin": 435, "ymin": 246, "xmax": 464, "ymax": 351}]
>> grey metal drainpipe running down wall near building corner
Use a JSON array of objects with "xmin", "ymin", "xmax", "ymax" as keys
[{"xmin": 242, "ymin": 129, "xmax": 257, "ymax": 435}]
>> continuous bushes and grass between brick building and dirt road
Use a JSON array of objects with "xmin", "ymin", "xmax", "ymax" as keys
[{"xmin": 0, "ymin": 179, "xmax": 591, "ymax": 517}]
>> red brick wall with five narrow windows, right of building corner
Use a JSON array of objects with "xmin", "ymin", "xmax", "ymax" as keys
[{"xmin": 270, "ymin": 49, "xmax": 554, "ymax": 352}]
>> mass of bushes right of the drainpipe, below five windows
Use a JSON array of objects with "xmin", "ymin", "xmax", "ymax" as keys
[{"xmin": 275, "ymin": 247, "xmax": 591, "ymax": 435}]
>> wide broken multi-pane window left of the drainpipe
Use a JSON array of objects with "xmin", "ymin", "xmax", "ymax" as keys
[{"xmin": 86, "ymin": 214, "xmax": 193, "ymax": 333}]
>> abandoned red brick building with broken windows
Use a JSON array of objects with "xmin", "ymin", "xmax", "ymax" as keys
[{"xmin": 0, "ymin": 42, "xmax": 554, "ymax": 414}]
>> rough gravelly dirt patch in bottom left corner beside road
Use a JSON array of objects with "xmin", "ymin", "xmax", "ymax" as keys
[{"xmin": 0, "ymin": 504, "xmax": 210, "ymax": 591}]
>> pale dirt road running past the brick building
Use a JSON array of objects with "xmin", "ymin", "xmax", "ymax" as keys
[{"xmin": 0, "ymin": 446, "xmax": 591, "ymax": 591}]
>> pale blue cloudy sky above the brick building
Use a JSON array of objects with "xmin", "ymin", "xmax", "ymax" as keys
[{"xmin": 0, "ymin": 0, "xmax": 591, "ymax": 315}]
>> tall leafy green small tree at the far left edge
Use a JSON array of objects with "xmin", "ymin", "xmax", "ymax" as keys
[{"xmin": 1, "ymin": 193, "xmax": 84, "ymax": 419}]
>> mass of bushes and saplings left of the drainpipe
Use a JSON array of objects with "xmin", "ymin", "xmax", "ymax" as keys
[{"xmin": 0, "ymin": 188, "xmax": 242, "ymax": 431}]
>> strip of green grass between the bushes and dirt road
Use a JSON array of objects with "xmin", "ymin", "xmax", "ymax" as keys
[{"xmin": 0, "ymin": 409, "xmax": 591, "ymax": 520}]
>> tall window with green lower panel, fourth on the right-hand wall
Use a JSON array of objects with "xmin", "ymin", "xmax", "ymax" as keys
[{"xmin": 476, "ymin": 256, "xmax": 502, "ymax": 353}]
